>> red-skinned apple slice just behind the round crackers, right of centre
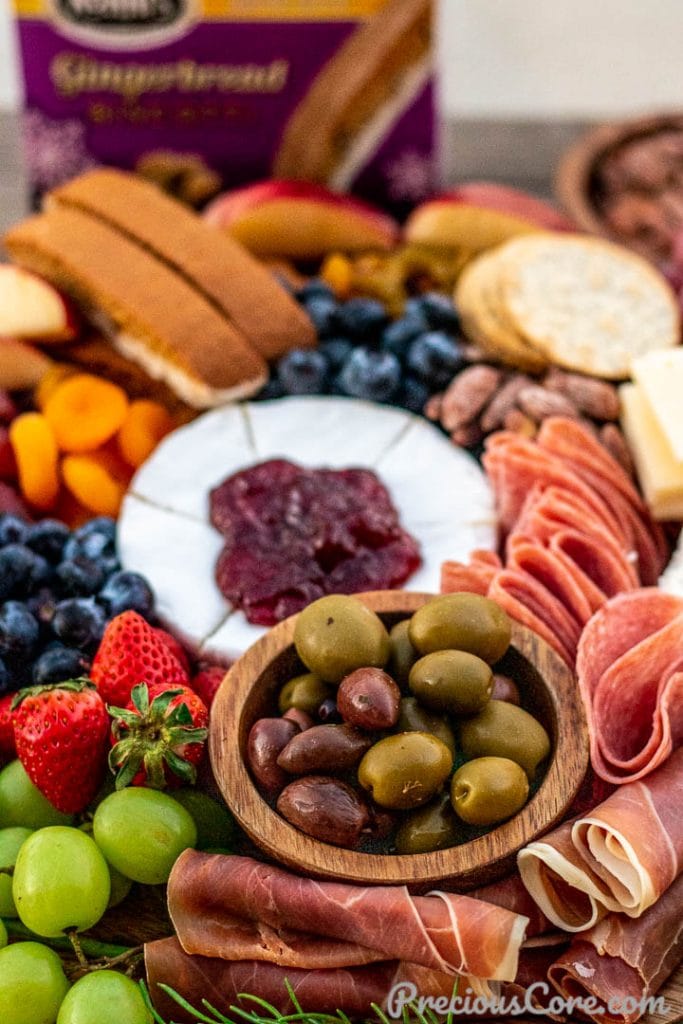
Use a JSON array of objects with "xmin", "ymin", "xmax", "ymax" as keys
[{"xmin": 405, "ymin": 181, "xmax": 573, "ymax": 252}]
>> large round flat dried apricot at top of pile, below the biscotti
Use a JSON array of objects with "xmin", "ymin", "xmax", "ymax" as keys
[{"xmin": 45, "ymin": 374, "xmax": 128, "ymax": 454}]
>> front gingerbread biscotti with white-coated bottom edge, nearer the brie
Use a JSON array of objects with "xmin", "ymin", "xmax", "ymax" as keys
[{"xmin": 4, "ymin": 207, "xmax": 267, "ymax": 409}]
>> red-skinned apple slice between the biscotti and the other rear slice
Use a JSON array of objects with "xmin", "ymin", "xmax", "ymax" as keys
[{"xmin": 205, "ymin": 179, "xmax": 400, "ymax": 259}]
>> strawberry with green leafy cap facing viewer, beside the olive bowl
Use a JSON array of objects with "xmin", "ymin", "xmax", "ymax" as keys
[{"xmin": 108, "ymin": 683, "xmax": 209, "ymax": 790}]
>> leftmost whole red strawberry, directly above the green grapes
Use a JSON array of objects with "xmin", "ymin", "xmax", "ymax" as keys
[{"xmin": 12, "ymin": 679, "xmax": 109, "ymax": 814}]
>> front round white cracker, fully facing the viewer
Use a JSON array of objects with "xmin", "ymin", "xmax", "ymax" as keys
[{"xmin": 499, "ymin": 234, "xmax": 680, "ymax": 380}]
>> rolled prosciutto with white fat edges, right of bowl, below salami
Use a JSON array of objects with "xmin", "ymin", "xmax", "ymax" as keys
[{"xmin": 517, "ymin": 748, "xmax": 683, "ymax": 932}]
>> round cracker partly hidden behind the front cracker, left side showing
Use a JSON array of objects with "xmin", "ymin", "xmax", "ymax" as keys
[{"xmin": 455, "ymin": 249, "xmax": 548, "ymax": 373}]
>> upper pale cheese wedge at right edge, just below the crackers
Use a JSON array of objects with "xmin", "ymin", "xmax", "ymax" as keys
[{"xmin": 631, "ymin": 346, "xmax": 683, "ymax": 462}]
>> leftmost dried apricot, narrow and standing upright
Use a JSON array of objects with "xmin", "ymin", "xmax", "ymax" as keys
[{"xmin": 9, "ymin": 413, "xmax": 59, "ymax": 510}]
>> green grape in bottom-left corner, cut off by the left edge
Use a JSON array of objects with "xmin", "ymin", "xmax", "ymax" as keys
[{"xmin": 0, "ymin": 942, "xmax": 69, "ymax": 1024}]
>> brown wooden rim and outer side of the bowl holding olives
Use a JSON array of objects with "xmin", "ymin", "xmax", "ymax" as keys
[{"xmin": 209, "ymin": 591, "xmax": 589, "ymax": 885}]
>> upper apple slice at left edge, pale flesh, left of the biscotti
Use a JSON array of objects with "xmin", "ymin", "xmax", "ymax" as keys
[{"xmin": 0, "ymin": 263, "xmax": 78, "ymax": 342}]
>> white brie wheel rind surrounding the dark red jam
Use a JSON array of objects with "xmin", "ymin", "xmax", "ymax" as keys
[{"xmin": 119, "ymin": 396, "xmax": 497, "ymax": 662}]
